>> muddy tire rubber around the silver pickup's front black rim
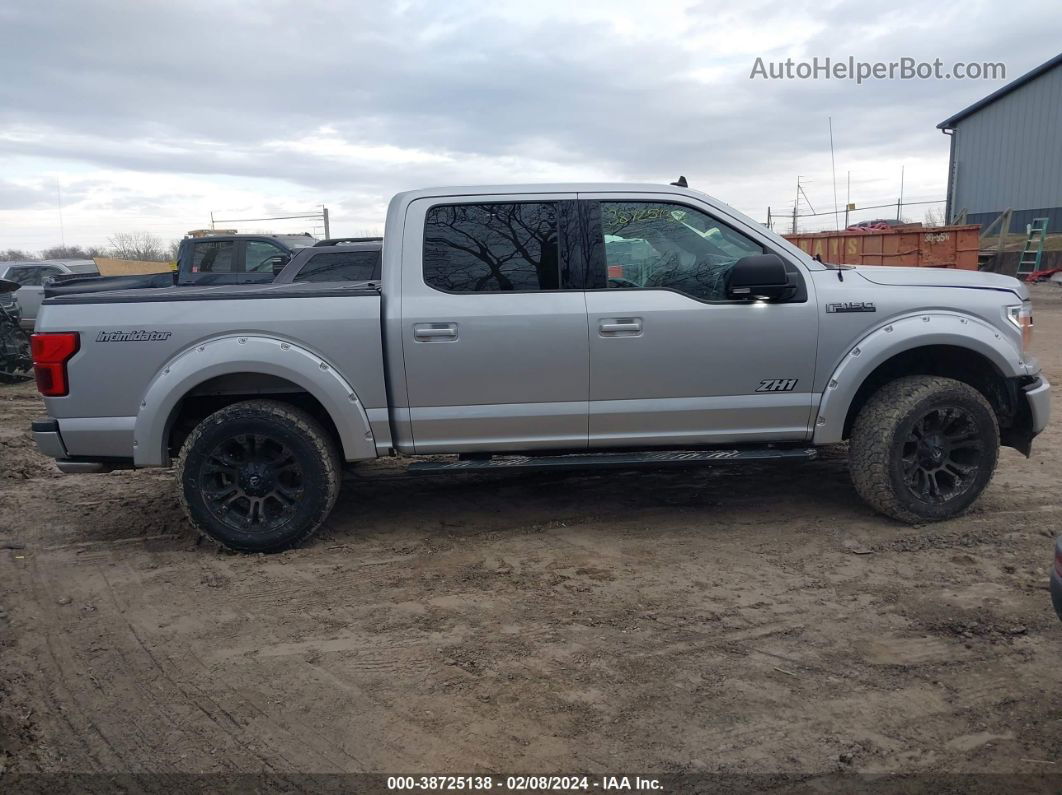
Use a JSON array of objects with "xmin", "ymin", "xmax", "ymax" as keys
[{"xmin": 849, "ymin": 376, "xmax": 999, "ymax": 523}]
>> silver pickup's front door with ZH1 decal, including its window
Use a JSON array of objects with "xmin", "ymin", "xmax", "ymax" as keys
[{"xmin": 583, "ymin": 195, "xmax": 818, "ymax": 448}]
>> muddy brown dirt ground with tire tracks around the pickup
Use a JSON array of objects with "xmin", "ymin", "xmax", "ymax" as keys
[{"xmin": 0, "ymin": 288, "xmax": 1062, "ymax": 774}]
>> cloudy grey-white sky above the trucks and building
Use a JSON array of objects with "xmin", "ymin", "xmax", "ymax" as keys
[{"xmin": 0, "ymin": 0, "xmax": 1062, "ymax": 250}]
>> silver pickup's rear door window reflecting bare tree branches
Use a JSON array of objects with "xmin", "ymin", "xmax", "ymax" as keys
[{"xmin": 424, "ymin": 202, "xmax": 561, "ymax": 293}]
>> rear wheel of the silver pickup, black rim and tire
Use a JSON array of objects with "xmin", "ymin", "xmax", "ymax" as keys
[{"xmin": 177, "ymin": 400, "xmax": 340, "ymax": 552}]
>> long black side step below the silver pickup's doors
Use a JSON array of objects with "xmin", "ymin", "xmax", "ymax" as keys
[{"xmin": 408, "ymin": 447, "xmax": 818, "ymax": 474}]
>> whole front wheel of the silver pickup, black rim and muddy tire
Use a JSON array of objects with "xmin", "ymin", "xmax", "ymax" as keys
[{"xmin": 849, "ymin": 376, "xmax": 999, "ymax": 522}]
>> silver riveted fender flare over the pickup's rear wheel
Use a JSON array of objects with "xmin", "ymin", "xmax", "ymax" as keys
[{"xmin": 133, "ymin": 335, "xmax": 376, "ymax": 467}]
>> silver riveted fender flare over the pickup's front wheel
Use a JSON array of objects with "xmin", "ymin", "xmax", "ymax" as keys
[{"xmin": 813, "ymin": 313, "xmax": 1025, "ymax": 445}]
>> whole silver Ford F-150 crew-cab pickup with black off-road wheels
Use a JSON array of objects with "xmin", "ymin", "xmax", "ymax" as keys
[{"xmin": 33, "ymin": 185, "xmax": 1050, "ymax": 551}]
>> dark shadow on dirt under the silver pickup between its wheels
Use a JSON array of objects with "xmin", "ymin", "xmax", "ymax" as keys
[{"xmin": 324, "ymin": 454, "xmax": 870, "ymax": 540}]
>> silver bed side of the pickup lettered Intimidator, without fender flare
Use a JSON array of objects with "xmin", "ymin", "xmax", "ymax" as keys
[{"xmin": 37, "ymin": 282, "xmax": 388, "ymax": 457}]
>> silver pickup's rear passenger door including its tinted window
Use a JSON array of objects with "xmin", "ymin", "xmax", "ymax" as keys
[{"xmin": 401, "ymin": 194, "xmax": 589, "ymax": 453}]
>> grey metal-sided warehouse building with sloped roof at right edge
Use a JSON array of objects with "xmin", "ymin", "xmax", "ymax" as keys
[{"xmin": 937, "ymin": 54, "xmax": 1062, "ymax": 231}]
